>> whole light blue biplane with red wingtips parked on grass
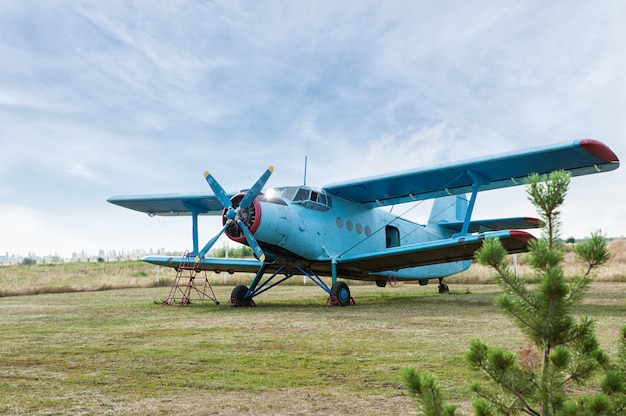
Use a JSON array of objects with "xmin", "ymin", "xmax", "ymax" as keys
[{"xmin": 108, "ymin": 139, "xmax": 619, "ymax": 306}]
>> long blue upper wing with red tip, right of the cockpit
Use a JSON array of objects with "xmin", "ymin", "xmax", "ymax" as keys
[{"xmin": 324, "ymin": 139, "xmax": 619, "ymax": 207}]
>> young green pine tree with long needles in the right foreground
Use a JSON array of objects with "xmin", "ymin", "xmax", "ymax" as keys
[{"xmin": 402, "ymin": 171, "xmax": 626, "ymax": 416}]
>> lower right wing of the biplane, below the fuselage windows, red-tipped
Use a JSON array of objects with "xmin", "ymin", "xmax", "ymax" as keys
[{"xmin": 337, "ymin": 231, "xmax": 534, "ymax": 276}]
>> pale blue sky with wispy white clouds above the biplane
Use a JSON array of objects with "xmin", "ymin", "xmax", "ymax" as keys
[{"xmin": 0, "ymin": 0, "xmax": 626, "ymax": 257}]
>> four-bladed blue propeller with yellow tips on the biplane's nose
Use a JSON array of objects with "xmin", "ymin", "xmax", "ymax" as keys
[{"xmin": 195, "ymin": 166, "xmax": 274, "ymax": 263}]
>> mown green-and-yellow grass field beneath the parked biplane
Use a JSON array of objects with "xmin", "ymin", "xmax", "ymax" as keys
[{"xmin": 0, "ymin": 276, "xmax": 626, "ymax": 415}]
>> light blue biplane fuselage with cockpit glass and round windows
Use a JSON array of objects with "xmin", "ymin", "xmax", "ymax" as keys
[{"xmin": 241, "ymin": 186, "xmax": 471, "ymax": 280}]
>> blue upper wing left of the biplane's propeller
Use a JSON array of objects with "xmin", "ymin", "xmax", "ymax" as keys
[{"xmin": 107, "ymin": 193, "xmax": 233, "ymax": 215}]
